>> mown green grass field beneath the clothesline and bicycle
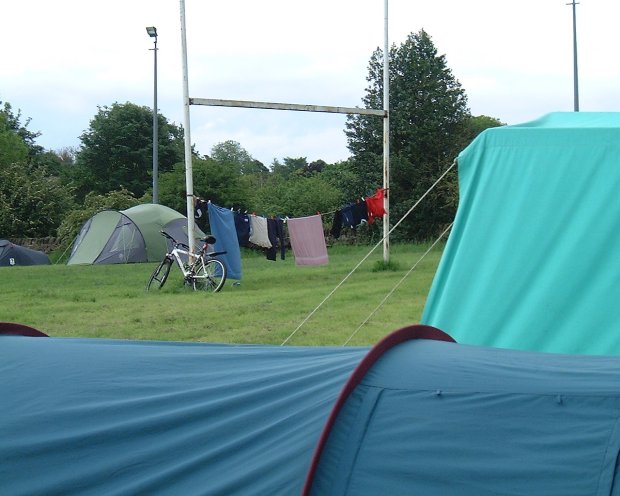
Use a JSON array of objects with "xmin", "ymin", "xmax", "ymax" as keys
[{"xmin": 0, "ymin": 245, "xmax": 442, "ymax": 345}]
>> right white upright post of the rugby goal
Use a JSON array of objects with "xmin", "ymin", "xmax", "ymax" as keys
[{"xmin": 383, "ymin": 0, "xmax": 390, "ymax": 263}]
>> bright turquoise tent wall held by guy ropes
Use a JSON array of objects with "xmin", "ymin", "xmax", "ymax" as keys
[{"xmin": 422, "ymin": 112, "xmax": 620, "ymax": 354}]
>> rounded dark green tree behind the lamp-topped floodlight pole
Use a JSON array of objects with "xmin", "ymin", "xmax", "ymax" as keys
[{"xmin": 73, "ymin": 102, "xmax": 184, "ymax": 198}]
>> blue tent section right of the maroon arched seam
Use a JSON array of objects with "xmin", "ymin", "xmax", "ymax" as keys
[{"xmin": 309, "ymin": 340, "xmax": 620, "ymax": 496}]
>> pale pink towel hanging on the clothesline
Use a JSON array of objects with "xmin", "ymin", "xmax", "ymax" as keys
[{"xmin": 288, "ymin": 215, "xmax": 329, "ymax": 265}]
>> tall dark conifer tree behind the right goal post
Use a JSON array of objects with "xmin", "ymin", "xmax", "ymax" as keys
[{"xmin": 345, "ymin": 30, "xmax": 470, "ymax": 240}]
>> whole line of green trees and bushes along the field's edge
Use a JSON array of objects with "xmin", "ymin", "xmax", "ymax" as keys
[{"xmin": 0, "ymin": 30, "xmax": 502, "ymax": 244}]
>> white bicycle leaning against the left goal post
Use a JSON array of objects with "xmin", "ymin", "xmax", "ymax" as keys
[{"xmin": 146, "ymin": 231, "xmax": 226, "ymax": 293}]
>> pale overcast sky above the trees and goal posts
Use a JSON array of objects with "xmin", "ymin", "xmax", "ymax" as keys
[{"xmin": 0, "ymin": 0, "xmax": 620, "ymax": 165}]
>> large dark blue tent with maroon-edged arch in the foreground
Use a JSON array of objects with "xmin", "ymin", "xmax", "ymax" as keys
[{"xmin": 0, "ymin": 326, "xmax": 620, "ymax": 496}]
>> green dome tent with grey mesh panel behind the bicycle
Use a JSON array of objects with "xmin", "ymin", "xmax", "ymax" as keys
[{"xmin": 67, "ymin": 203, "xmax": 204, "ymax": 265}]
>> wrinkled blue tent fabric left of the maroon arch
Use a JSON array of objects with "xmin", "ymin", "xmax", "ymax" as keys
[{"xmin": 0, "ymin": 336, "xmax": 367, "ymax": 496}]
